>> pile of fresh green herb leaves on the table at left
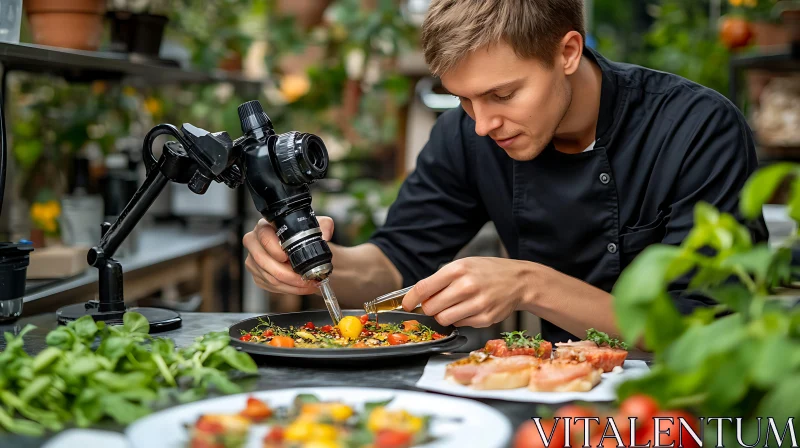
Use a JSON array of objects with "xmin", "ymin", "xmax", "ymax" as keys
[{"xmin": 0, "ymin": 312, "xmax": 258, "ymax": 436}]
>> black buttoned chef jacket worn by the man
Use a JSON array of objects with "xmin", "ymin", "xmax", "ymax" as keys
[{"xmin": 371, "ymin": 48, "xmax": 767, "ymax": 342}]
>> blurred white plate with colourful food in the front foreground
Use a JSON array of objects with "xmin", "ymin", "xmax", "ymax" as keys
[{"xmin": 126, "ymin": 387, "xmax": 512, "ymax": 448}]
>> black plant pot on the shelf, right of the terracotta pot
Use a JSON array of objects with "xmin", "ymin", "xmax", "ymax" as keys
[{"xmin": 106, "ymin": 0, "xmax": 174, "ymax": 57}]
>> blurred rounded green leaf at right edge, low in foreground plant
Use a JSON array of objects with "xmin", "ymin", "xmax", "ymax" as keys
[{"xmin": 749, "ymin": 335, "xmax": 800, "ymax": 390}]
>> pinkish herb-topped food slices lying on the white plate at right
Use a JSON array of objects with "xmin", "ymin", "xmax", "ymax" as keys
[{"xmin": 445, "ymin": 329, "xmax": 628, "ymax": 392}]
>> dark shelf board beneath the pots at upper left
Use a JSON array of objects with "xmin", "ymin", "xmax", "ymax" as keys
[{"xmin": 0, "ymin": 43, "xmax": 261, "ymax": 87}]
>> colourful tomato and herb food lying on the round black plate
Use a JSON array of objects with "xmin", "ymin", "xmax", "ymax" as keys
[{"xmin": 239, "ymin": 314, "xmax": 445, "ymax": 349}]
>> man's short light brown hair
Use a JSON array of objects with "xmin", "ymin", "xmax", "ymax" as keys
[{"xmin": 422, "ymin": 0, "xmax": 586, "ymax": 76}]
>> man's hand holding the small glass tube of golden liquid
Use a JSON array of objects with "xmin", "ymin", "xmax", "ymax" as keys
[{"xmin": 403, "ymin": 257, "xmax": 536, "ymax": 328}]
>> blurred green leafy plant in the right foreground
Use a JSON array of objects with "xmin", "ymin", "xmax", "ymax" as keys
[{"xmin": 612, "ymin": 163, "xmax": 800, "ymax": 434}]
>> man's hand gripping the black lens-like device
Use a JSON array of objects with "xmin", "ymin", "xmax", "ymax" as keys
[{"xmin": 242, "ymin": 216, "xmax": 333, "ymax": 295}]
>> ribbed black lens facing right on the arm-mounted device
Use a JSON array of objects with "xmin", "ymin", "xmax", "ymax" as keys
[{"xmin": 275, "ymin": 132, "xmax": 328, "ymax": 185}]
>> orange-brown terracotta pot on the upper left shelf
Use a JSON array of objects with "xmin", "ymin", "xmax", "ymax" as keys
[{"xmin": 25, "ymin": 0, "xmax": 106, "ymax": 51}]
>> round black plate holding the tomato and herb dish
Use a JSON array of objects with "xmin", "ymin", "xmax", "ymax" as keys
[{"xmin": 228, "ymin": 310, "xmax": 467, "ymax": 365}]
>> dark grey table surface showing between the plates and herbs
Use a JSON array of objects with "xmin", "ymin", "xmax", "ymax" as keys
[{"xmin": 0, "ymin": 313, "xmax": 651, "ymax": 448}]
